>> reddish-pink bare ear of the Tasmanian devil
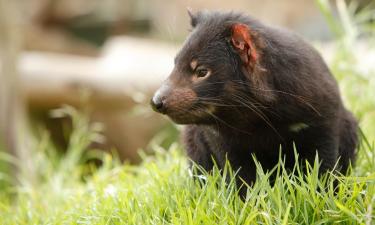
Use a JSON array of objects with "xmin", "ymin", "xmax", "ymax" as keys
[{"xmin": 232, "ymin": 23, "xmax": 258, "ymax": 68}]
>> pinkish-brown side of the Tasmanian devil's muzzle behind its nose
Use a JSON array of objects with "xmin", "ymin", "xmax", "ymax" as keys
[{"xmin": 165, "ymin": 88, "xmax": 198, "ymax": 114}]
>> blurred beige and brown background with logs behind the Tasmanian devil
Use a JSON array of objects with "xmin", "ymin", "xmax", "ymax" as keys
[{"xmin": 0, "ymin": 0, "xmax": 375, "ymax": 168}]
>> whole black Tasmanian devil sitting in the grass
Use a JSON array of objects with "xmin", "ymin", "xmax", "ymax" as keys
[{"xmin": 151, "ymin": 11, "xmax": 358, "ymax": 189}]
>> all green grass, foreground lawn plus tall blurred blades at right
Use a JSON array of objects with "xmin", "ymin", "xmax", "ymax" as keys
[{"xmin": 0, "ymin": 1, "xmax": 375, "ymax": 225}]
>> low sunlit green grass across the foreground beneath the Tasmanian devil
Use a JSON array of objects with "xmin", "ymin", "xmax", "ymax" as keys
[{"xmin": 0, "ymin": 125, "xmax": 375, "ymax": 224}]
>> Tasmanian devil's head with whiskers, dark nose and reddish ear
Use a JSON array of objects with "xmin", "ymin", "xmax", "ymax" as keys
[{"xmin": 151, "ymin": 12, "xmax": 273, "ymax": 124}]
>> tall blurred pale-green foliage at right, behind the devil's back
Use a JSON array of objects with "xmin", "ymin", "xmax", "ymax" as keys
[{"xmin": 317, "ymin": 0, "xmax": 375, "ymax": 140}]
